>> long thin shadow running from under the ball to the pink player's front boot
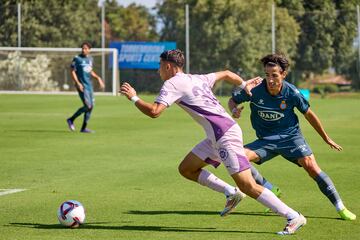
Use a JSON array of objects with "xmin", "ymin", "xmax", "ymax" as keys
[{"xmin": 10, "ymin": 223, "xmax": 275, "ymax": 235}]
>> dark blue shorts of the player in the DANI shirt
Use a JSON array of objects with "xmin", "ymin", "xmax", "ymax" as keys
[{"xmin": 244, "ymin": 135, "xmax": 312, "ymax": 166}]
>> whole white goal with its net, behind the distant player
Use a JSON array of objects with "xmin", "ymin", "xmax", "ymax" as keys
[{"xmin": 0, "ymin": 47, "xmax": 119, "ymax": 95}]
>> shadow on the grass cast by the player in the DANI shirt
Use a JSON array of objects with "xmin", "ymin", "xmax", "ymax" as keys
[{"xmin": 126, "ymin": 210, "xmax": 342, "ymax": 220}]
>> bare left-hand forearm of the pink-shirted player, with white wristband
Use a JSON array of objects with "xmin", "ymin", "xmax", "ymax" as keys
[{"xmin": 120, "ymin": 83, "xmax": 166, "ymax": 118}]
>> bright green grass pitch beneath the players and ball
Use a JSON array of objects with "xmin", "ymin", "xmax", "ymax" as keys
[{"xmin": 0, "ymin": 94, "xmax": 360, "ymax": 240}]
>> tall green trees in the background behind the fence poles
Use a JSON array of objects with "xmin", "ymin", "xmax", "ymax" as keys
[{"xmin": 0, "ymin": 0, "xmax": 360, "ymax": 88}]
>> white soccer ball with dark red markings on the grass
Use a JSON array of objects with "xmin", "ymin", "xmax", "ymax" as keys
[{"xmin": 58, "ymin": 200, "xmax": 85, "ymax": 228}]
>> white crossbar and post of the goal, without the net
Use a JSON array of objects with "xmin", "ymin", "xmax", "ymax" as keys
[{"xmin": 0, "ymin": 47, "xmax": 120, "ymax": 96}]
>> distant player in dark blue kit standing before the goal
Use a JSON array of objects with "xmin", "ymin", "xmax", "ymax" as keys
[{"xmin": 66, "ymin": 42, "xmax": 105, "ymax": 133}]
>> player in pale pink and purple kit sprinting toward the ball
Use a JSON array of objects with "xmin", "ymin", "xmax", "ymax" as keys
[{"xmin": 121, "ymin": 50, "xmax": 306, "ymax": 234}]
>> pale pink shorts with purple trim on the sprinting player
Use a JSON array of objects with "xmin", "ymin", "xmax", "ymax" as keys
[{"xmin": 192, "ymin": 124, "xmax": 250, "ymax": 175}]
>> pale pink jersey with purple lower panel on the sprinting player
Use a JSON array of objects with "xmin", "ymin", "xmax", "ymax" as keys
[{"xmin": 155, "ymin": 73, "xmax": 236, "ymax": 142}]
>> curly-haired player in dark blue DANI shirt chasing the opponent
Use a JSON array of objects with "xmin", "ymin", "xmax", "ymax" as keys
[{"xmin": 228, "ymin": 54, "xmax": 356, "ymax": 220}]
